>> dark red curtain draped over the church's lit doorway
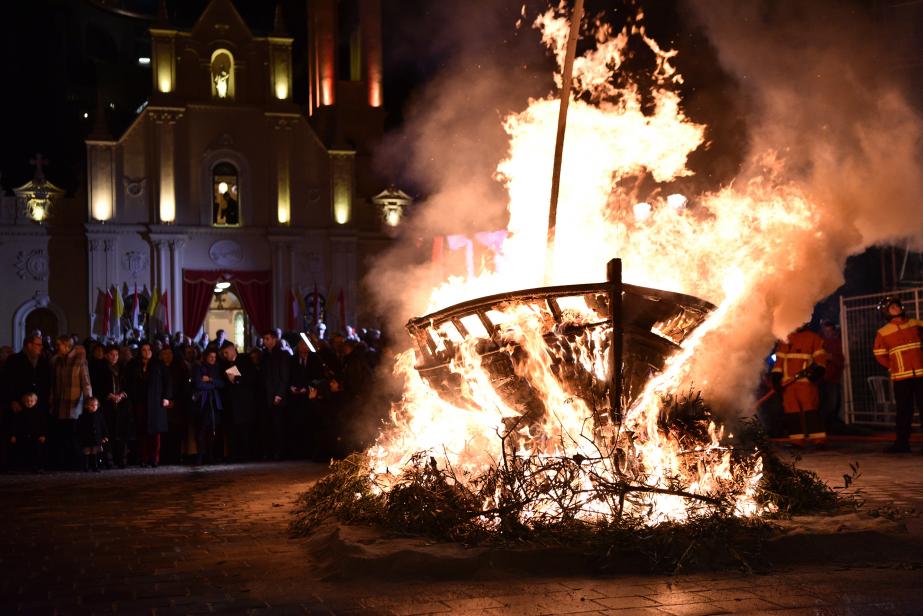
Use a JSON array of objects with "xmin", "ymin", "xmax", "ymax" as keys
[{"xmin": 183, "ymin": 269, "xmax": 272, "ymax": 336}]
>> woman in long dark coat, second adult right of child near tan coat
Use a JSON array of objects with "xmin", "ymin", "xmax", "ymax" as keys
[{"xmin": 128, "ymin": 342, "xmax": 173, "ymax": 467}]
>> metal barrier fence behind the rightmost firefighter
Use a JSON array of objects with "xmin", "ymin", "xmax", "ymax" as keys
[{"xmin": 840, "ymin": 288, "xmax": 923, "ymax": 428}]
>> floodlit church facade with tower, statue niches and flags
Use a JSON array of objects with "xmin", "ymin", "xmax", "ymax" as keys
[{"xmin": 0, "ymin": 0, "xmax": 406, "ymax": 348}]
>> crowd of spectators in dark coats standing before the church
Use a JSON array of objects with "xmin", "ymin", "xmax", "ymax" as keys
[{"xmin": 0, "ymin": 329, "xmax": 388, "ymax": 472}]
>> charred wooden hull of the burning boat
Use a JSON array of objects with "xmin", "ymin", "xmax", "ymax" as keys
[{"xmin": 407, "ymin": 268, "xmax": 714, "ymax": 424}]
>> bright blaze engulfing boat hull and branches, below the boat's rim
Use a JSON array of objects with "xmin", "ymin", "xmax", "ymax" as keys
[{"xmin": 368, "ymin": 276, "xmax": 761, "ymax": 528}]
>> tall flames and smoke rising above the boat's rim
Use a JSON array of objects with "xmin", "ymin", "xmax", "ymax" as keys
[{"xmin": 370, "ymin": 0, "xmax": 923, "ymax": 414}]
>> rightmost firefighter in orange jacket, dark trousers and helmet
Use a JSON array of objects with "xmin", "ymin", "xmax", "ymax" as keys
[{"xmin": 874, "ymin": 297, "xmax": 923, "ymax": 453}]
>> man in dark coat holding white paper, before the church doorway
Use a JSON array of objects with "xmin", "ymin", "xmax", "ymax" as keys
[{"xmin": 221, "ymin": 340, "xmax": 259, "ymax": 462}]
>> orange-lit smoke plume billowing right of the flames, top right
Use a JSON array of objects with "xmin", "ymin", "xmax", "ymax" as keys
[{"xmin": 691, "ymin": 0, "xmax": 923, "ymax": 414}]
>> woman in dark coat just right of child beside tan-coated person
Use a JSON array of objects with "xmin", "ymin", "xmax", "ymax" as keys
[{"xmin": 90, "ymin": 346, "xmax": 135, "ymax": 468}]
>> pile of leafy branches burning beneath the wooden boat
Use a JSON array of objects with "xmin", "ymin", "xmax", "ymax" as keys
[{"xmin": 292, "ymin": 392, "xmax": 860, "ymax": 571}]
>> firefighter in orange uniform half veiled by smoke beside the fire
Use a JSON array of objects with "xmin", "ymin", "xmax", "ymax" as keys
[{"xmin": 772, "ymin": 325, "xmax": 827, "ymax": 445}]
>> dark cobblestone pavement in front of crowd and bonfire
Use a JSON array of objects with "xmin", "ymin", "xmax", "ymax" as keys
[{"xmin": 0, "ymin": 450, "xmax": 923, "ymax": 616}]
